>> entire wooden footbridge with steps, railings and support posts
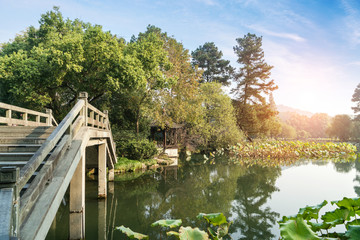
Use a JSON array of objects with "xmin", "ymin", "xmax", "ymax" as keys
[{"xmin": 0, "ymin": 92, "xmax": 116, "ymax": 240}]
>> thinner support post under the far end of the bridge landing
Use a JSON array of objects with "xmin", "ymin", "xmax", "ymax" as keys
[{"xmin": 98, "ymin": 143, "xmax": 107, "ymax": 198}]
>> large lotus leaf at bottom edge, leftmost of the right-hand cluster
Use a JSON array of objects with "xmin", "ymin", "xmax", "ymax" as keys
[{"xmin": 280, "ymin": 216, "xmax": 321, "ymax": 240}]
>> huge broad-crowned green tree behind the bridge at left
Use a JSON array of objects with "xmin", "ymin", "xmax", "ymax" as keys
[{"xmin": 0, "ymin": 7, "xmax": 124, "ymax": 117}]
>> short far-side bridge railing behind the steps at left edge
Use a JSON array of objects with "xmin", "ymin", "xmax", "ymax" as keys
[{"xmin": 0, "ymin": 103, "xmax": 57, "ymax": 126}]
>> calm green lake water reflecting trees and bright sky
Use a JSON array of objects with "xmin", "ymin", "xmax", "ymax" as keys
[{"xmin": 47, "ymin": 158, "xmax": 360, "ymax": 240}]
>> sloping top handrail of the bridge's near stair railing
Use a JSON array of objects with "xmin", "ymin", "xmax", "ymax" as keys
[{"xmin": 18, "ymin": 100, "xmax": 85, "ymax": 189}]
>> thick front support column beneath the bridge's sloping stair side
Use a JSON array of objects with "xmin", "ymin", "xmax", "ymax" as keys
[{"xmin": 69, "ymin": 153, "xmax": 85, "ymax": 239}]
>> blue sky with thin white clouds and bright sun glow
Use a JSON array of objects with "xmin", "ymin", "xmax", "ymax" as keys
[{"xmin": 0, "ymin": 0, "xmax": 360, "ymax": 116}]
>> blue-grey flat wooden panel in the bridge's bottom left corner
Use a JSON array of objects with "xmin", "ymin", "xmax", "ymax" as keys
[{"xmin": 0, "ymin": 188, "xmax": 14, "ymax": 239}]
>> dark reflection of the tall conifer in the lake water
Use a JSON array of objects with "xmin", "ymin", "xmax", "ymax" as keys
[{"xmin": 231, "ymin": 166, "xmax": 281, "ymax": 239}]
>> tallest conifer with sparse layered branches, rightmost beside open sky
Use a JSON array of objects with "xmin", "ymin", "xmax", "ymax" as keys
[{"xmin": 232, "ymin": 33, "xmax": 278, "ymax": 139}]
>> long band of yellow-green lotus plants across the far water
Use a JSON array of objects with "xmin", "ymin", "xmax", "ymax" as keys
[{"xmin": 229, "ymin": 141, "xmax": 356, "ymax": 166}]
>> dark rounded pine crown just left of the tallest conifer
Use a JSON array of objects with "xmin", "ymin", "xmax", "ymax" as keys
[{"xmin": 191, "ymin": 42, "xmax": 235, "ymax": 86}]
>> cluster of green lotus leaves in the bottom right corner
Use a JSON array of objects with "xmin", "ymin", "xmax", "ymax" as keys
[{"xmin": 279, "ymin": 197, "xmax": 360, "ymax": 240}]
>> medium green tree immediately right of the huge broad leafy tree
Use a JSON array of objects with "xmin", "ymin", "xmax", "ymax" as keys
[{"xmin": 115, "ymin": 30, "xmax": 177, "ymax": 133}]
